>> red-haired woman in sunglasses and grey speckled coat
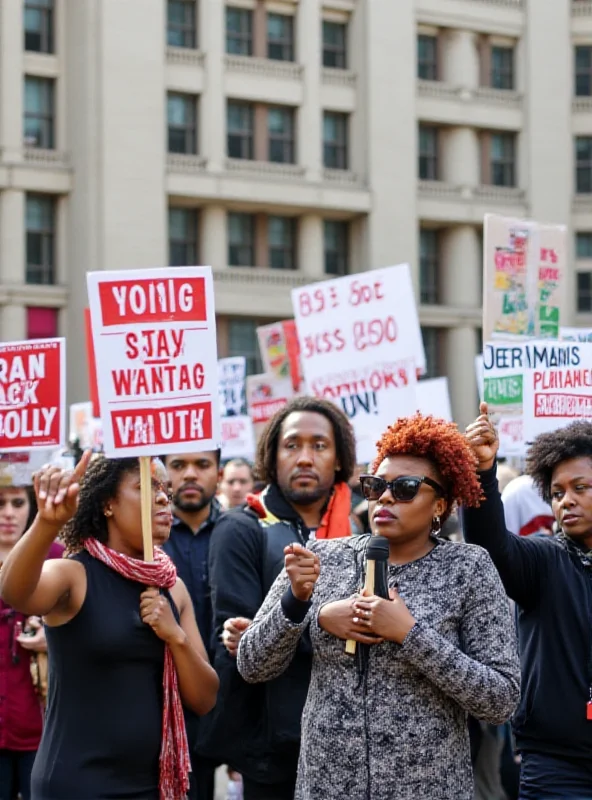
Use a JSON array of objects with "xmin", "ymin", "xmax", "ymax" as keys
[{"xmin": 238, "ymin": 414, "xmax": 519, "ymax": 800}]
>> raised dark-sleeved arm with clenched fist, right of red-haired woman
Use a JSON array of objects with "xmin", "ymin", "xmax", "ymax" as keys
[{"xmin": 460, "ymin": 403, "xmax": 549, "ymax": 608}]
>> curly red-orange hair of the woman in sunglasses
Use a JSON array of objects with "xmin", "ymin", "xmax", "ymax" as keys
[{"xmin": 372, "ymin": 414, "xmax": 483, "ymax": 524}]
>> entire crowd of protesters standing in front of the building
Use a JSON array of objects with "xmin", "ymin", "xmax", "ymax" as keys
[{"xmin": 0, "ymin": 397, "xmax": 592, "ymax": 800}]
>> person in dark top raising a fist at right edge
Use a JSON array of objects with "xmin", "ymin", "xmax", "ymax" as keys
[{"xmin": 464, "ymin": 403, "xmax": 592, "ymax": 800}]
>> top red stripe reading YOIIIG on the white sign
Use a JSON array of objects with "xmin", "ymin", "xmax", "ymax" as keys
[{"xmin": 99, "ymin": 278, "xmax": 207, "ymax": 327}]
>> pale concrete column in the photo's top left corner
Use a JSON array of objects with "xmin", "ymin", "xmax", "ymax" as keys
[{"xmin": 0, "ymin": 0, "xmax": 24, "ymax": 161}]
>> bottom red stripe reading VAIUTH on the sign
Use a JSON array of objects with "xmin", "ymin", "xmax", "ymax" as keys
[{"xmin": 110, "ymin": 402, "xmax": 212, "ymax": 450}]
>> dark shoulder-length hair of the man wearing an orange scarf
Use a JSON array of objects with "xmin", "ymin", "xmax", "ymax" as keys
[{"xmin": 255, "ymin": 397, "xmax": 356, "ymax": 483}]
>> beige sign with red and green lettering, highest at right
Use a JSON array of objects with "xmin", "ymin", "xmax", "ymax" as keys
[{"xmin": 483, "ymin": 214, "xmax": 567, "ymax": 342}]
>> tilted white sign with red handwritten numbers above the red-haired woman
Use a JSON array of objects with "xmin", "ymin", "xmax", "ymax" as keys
[{"xmin": 292, "ymin": 264, "xmax": 425, "ymax": 462}]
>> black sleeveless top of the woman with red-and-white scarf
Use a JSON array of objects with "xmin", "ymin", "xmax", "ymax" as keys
[{"xmin": 31, "ymin": 552, "xmax": 165, "ymax": 800}]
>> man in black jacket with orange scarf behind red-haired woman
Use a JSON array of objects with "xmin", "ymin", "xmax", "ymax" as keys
[{"xmin": 200, "ymin": 397, "xmax": 355, "ymax": 800}]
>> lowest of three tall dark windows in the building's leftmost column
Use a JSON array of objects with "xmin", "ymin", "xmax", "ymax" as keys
[{"xmin": 26, "ymin": 194, "xmax": 55, "ymax": 285}]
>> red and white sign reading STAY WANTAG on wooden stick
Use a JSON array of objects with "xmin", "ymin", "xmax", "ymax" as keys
[{"xmin": 87, "ymin": 267, "xmax": 220, "ymax": 457}]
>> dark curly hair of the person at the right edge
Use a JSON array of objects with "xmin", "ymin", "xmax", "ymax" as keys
[{"xmin": 526, "ymin": 420, "xmax": 592, "ymax": 503}]
